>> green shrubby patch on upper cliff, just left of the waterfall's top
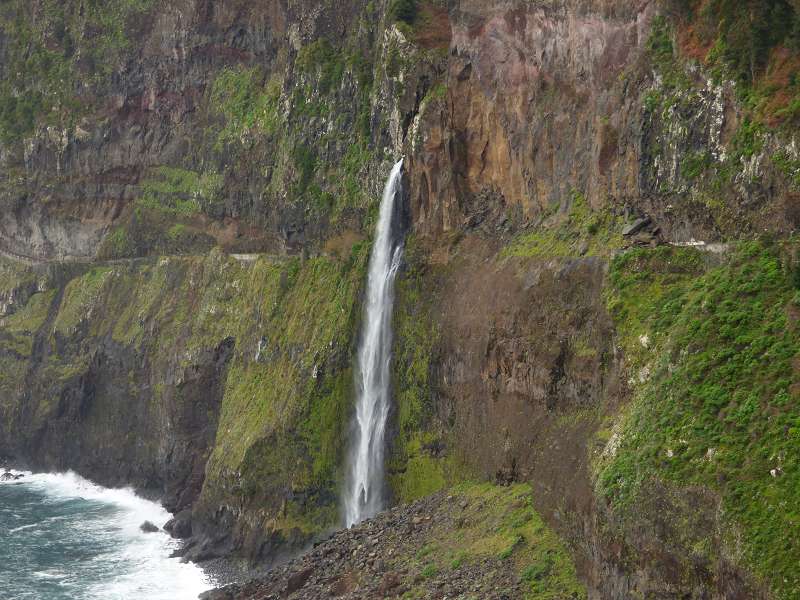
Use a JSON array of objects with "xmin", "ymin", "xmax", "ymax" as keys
[{"xmin": 209, "ymin": 29, "xmax": 376, "ymax": 229}]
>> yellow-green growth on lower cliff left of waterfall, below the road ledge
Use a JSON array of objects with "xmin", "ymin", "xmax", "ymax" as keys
[{"xmin": 0, "ymin": 244, "xmax": 369, "ymax": 537}]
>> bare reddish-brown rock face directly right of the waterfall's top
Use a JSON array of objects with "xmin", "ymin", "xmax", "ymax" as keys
[{"xmin": 410, "ymin": 2, "xmax": 655, "ymax": 238}]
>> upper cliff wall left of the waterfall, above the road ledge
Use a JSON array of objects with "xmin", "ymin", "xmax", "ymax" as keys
[{"xmin": 0, "ymin": 0, "xmax": 421, "ymax": 260}]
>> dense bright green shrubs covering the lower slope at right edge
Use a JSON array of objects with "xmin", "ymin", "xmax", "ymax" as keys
[{"xmin": 600, "ymin": 242, "xmax": 800, "ymax": 599}]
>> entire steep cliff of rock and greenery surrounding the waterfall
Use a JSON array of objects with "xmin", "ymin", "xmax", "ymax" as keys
[{"xmin": 0, "ymin": 0, "xmax": 800, "ymax": 598}]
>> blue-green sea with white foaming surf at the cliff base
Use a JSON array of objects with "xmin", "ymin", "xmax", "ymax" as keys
[{"xmin": 0, "ymin": 473, "xmax": 213, "ymax": 600}]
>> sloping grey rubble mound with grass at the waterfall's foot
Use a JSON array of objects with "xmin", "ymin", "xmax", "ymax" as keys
[{"xmin": 200, "ymin": 485, "xmax": 586, "ymax": 600}]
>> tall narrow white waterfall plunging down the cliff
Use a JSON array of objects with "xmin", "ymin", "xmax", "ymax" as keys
[{"xmin": 344, "ymin": 159, "xmax": 403, "ymax": 527}]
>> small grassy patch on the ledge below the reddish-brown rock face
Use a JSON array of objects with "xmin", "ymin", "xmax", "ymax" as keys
[{"xmin": 501, "ymin": 191, "xmax": 623, "ymax": 258}]
